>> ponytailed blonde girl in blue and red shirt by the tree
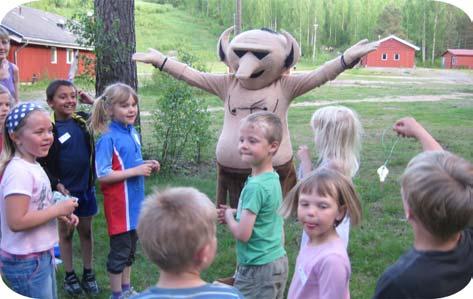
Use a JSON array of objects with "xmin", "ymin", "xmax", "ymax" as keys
[{"xmin": 90, "ymin": 83, "xmax": 159, "ymax": 299}]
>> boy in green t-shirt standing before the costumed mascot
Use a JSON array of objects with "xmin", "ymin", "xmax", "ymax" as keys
[{"xmin": 218, "ymin": 112, "xmax": 288, "ymax": 298}]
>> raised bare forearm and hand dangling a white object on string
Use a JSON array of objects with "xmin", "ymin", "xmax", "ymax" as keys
[{"xmin": 393, "ymin": 117, "xmax": 443, "ymax": 151}]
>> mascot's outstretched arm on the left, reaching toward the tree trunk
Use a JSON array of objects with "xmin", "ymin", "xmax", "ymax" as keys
[{"xmin": 132, "ymin": 49, "xmax": 230, "ymax": 100}]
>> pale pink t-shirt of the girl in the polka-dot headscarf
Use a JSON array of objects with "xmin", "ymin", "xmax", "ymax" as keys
[{"xmin": 0, "ymin": 157, "xmax": 58, "ymax": 254}]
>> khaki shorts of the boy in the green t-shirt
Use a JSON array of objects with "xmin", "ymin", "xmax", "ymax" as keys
[{"xmin": 233, "ymin": 256, "xmax": 289, "ymax": 299}]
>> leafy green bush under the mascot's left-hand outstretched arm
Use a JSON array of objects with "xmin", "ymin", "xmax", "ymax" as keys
[{"xmin": 152, "ymin": 50, "xmax": 212, "ymax": 173}]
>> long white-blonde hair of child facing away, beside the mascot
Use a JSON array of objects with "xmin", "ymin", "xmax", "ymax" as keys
[{"xmin": 310, "ymin": 106, "xmax": 363, "ymax": 177}]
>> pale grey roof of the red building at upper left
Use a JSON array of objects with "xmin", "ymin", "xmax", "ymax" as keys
[{"xmin": 1, "ymin": 6, "xmax": 92, "ymax": 50}]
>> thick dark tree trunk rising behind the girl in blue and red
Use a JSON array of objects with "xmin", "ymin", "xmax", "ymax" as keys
[{"xmin": 94, "ymin": 0, "xmax": 140, "ymax": 129}]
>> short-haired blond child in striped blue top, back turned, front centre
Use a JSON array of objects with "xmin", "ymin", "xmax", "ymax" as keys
[{"xmin": 133, "ymin": 188, "xmax": 243, "ymax": 299}]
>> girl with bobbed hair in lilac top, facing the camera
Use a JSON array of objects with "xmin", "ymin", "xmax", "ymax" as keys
[{"xmin": 281, "ymin": 166, "xmax": 361, "ymax": 299}]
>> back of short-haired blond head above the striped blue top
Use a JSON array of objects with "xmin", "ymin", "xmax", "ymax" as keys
[{"xmin": 137, "ymin": 188, "xmax": 217, "ymax": 273}]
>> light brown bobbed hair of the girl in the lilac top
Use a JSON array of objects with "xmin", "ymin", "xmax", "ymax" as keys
[{"xmin": 280, "ymin": 166, "xmax": 362, "ymax": 225}]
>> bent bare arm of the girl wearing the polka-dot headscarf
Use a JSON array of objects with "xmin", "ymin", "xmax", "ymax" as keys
[{"xmin": 5, "ymin": 194, "xmax": 78, "ymax": 232}]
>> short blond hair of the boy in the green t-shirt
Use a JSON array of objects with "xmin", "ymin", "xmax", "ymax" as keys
[{"xmin": 241, "ymin": 112, "xmax": 283, "ymax": 144}]
